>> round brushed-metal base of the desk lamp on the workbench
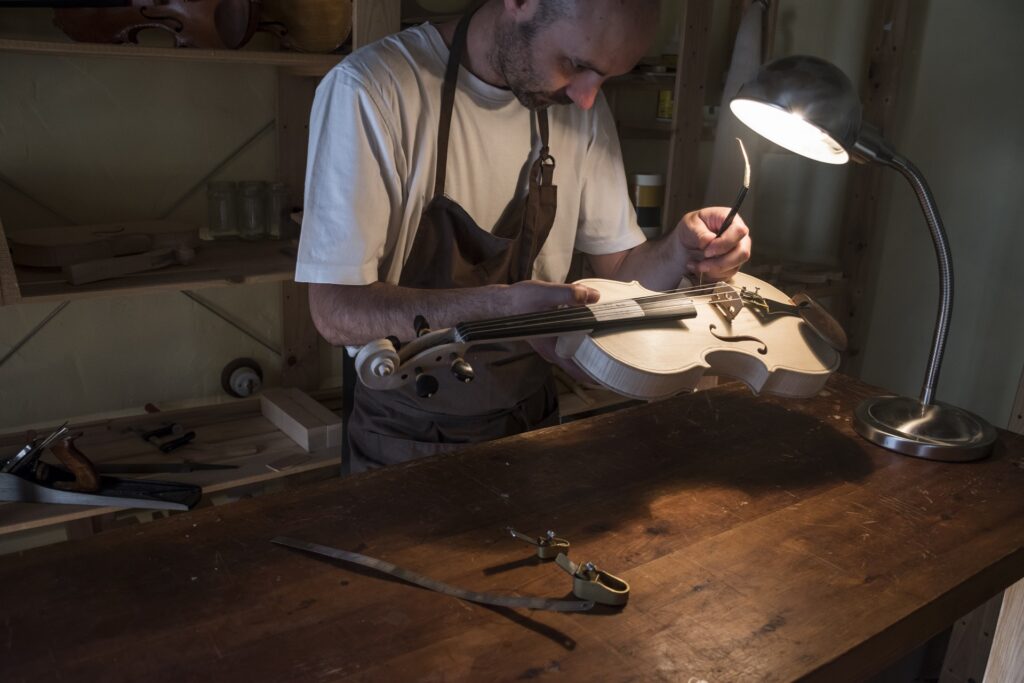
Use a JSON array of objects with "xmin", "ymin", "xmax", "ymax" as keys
[{"xmin": 853, "ymin": 396, "xmax": 996, "ymax": 462}]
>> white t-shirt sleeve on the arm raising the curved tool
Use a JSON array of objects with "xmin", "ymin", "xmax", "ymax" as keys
[{"xmin": 575, "ymin": 95, "xmax": 646, "ymax": 255}]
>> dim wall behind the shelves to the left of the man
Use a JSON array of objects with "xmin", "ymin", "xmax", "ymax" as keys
[{"xmin": 0, "ymin": 9, "xmax": 281, "ymax": 429}]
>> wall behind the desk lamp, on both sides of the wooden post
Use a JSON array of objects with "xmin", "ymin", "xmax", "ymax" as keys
[{"xmin": 752, "ymin": 0, "xmax": 1024, "ymax": 426}]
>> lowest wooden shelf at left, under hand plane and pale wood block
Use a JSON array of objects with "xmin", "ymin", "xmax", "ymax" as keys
[{"xmin": 0, "ymin": 391, "xmax": 341, "ymax": 537}]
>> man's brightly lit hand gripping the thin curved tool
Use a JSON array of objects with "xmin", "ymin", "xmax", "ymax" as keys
[{"xmin": 676, "ymin": 207, "xmax": 751, "ymax": 280}]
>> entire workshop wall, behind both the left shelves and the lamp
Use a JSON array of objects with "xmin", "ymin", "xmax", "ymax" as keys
[{"xmin": 0, "ymin": 0, "xmax": 1024, "ymax": 436}]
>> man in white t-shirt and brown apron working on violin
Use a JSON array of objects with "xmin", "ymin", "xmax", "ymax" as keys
[{"xmin": 296, "ymin": 0, "xmax": 750, "ymax": 471}]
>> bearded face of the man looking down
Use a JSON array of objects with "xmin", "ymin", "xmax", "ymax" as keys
[{"xmin": 492, "ymin": 1, "xmax": 656, "ymax": 110}]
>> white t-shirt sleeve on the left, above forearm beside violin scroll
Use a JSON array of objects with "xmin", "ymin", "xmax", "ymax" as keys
[{"xmin": 295, "ymin": 65, "xmax": 401, "ymax": 285}]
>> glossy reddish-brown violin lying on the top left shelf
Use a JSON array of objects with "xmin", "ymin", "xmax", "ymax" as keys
[{"xmin": 50, "ymin": 0, "xmax": 260, "ymax": 49}]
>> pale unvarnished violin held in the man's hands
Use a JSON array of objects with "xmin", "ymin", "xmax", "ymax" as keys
[{"xmin": 355, "ymin": 273, "xmax": 847, "ymax": 400}]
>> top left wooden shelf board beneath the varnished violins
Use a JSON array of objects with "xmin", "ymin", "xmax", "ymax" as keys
[{"xmin": 0, "ymin": 38, "xmax": 345, "ymax": 76}]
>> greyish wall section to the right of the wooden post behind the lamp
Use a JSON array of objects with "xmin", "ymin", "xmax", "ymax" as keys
[{"xmin": 861, "ymin": 0, "xmax": 1024, "ymax": 427}]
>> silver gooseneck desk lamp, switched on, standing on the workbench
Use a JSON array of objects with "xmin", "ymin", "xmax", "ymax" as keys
[{"xmin": 729, "ymin": 55, "xmax": 995, "ymax": 461}]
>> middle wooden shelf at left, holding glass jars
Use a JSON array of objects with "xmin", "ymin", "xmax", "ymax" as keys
[{"xmin": 4, "ymin": 240, "xmax": 295, "ymax": 303}]
